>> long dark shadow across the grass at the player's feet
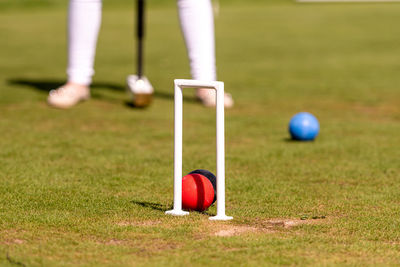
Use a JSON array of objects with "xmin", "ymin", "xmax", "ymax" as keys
[{"xmin": 7, "ymin": 78, "xmax": 197, "ymax": 103}]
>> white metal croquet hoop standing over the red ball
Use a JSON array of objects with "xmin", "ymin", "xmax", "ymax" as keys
[{"xmin": 165, "ymin": 79, "xmax": 233, "ymax": 220}]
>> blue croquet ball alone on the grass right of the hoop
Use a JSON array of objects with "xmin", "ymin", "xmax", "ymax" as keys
[{"xmin": 289, "ymin": 112, "xmax": 319, "ymax": 141}]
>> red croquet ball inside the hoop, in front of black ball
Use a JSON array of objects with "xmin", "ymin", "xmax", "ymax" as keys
[{"xmin": 182, "ymin": 173, "xmax": 215, "ymax": 211}]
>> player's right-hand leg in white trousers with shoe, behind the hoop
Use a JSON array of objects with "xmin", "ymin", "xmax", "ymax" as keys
[{"xmin": 177, "ymin": 0, "xmax": 233, "ymax": 107}]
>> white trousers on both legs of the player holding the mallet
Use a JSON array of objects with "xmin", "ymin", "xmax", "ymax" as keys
[{"xmin": 67, "ymin": 0, "xmax": 216, "ymax": 85}]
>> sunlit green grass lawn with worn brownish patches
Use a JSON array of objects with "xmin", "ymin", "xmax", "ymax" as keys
[{"xmin": 0, "ymin": 0, "xmax": 400, "ymax": 266}]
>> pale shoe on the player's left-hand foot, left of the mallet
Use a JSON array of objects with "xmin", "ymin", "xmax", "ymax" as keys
[{"xmin": 47, "ymin": 85, "xmax": 90, "ymax": 108}]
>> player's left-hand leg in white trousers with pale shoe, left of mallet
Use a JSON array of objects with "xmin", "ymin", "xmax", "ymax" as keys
[{"xmin": 48, "ymin": 0, "xmax": 102, "ymax": 108}]
